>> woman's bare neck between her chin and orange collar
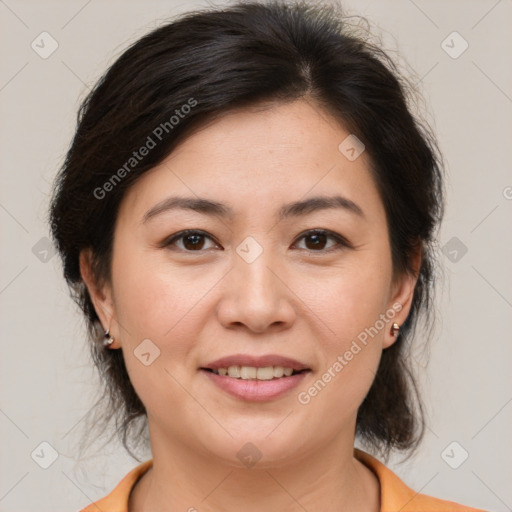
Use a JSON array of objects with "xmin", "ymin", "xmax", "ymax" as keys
[{"xmin": 128, "ymin": 428, "xmax": 380, "ymax": 512}]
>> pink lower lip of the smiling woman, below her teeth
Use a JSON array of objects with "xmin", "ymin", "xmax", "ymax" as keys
[{"xmin": 201, "ymin": 369, "xmax": 309, "ymax": 402}]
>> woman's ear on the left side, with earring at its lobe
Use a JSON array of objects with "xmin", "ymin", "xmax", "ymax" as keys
[{"xmin": 80, "ymin": 249, "xmax": 120, "ymax": 348}]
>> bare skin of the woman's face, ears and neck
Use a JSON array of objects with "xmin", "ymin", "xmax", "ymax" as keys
[{"xmin": 81, "ymin": 99, "xmax": 419, "ymax": 512}]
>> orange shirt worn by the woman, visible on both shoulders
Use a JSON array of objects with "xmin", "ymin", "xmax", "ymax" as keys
[{"xmin": 80, "ymin": 448, "xmax": 485, "ymax": 512}]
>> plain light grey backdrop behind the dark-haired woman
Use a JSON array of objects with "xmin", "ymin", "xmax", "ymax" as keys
[{"xmin": 0, "ymin": 0, "xmax": 512, "ymax": 512}]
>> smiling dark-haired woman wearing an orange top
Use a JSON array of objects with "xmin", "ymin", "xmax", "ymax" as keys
[{"xmin": 51, "ymin": 2, "xmax": 486, "ymax": 512}]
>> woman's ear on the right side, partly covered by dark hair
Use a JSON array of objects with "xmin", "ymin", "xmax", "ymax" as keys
[{"xmin": 382, "ymin": 241, "xmax": 422, "ymax": 349}]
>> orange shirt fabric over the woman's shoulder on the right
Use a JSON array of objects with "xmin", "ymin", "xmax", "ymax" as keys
[{"xmin": 354, "ymin": 448, "xmax": 485, "ymax": 512}]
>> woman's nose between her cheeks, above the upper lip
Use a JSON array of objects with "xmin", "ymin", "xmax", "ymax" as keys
[{"xmin": 217, "ymin": 246, "xmax": 296, "ymax": 333}]
